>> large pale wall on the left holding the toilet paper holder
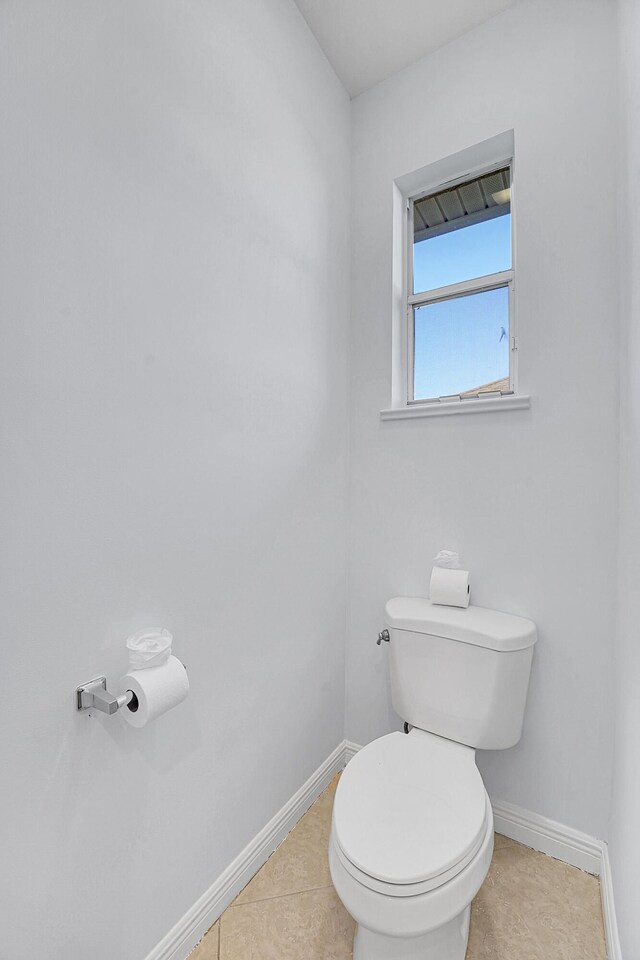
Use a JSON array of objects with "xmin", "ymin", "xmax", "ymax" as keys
[{"xmin": 0, "ymin": 0, "xmax": 349, "ymax": 960}]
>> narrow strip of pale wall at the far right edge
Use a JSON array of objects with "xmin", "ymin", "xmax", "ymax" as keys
[{"xmin": 611, "ymin": 0, "xmax": 640, "ymax": 948}]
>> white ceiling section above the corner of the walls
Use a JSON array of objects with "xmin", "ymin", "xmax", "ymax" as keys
[{"xmin": 296, "ymin": 0, "xmax": 514, "ymax": 97}]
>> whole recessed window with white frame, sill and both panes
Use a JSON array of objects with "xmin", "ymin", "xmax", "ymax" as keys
[{"xmin": 380, "ymin": 130, "xmax": 531, "ymax": 420}]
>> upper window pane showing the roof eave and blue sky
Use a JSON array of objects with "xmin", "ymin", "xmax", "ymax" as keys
[{"xmin": 413, "ymin": 167, "xmax": 511, "ymax": 293}]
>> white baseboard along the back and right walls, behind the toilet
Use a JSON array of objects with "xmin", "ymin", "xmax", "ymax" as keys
[{"xmin": 345, "ymin": 740, "xmax": 622, "ymax": 960}]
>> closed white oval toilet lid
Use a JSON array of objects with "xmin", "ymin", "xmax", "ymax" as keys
[{"xmin": 333, "ymin": 730, "xmax": 487, "ymax": 885}]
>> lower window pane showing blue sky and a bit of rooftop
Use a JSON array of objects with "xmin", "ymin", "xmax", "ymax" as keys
[{"xmin": 413, "ymin": 287, "xmax": 509, "ymax": 400}]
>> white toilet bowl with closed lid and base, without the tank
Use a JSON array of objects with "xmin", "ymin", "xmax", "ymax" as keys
[{"xmin": 329, "ymin": 729, "xmax": 493, "ymax": 960}]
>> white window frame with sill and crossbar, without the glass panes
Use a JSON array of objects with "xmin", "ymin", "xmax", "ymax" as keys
[{"xmin": 380, "ymin": 131, "xmax": 530, "ymax": 420}]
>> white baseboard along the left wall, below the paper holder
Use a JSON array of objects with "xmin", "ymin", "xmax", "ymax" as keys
[{"xmin": 146, "ymin": 740, "xmax": 348, "ymax": 960}]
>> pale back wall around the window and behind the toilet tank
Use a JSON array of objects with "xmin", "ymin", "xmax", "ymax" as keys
[{"xmin": 347, "ymin": 0, "xmax": 618, "ymax": 837}]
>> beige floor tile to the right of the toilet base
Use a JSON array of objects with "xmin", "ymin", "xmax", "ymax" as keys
[{"xmin": 467, "ymin": 836, "xmax": 606, "ymax": 960}]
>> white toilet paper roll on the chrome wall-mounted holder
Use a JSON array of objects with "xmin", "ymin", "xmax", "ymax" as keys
[{"xmin": 122, "ymin": 657, "xmax": 189, "ymax": 727}]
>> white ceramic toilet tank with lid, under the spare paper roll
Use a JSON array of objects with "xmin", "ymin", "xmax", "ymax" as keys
[{"xmin": 385, "ymin": 597, "xmax": 536, "ymax": 750}]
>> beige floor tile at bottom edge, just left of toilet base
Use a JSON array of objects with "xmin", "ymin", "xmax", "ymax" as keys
[{"xmin": 220, "ymin": 887, "xmax": 354, "ymax": 960}]
